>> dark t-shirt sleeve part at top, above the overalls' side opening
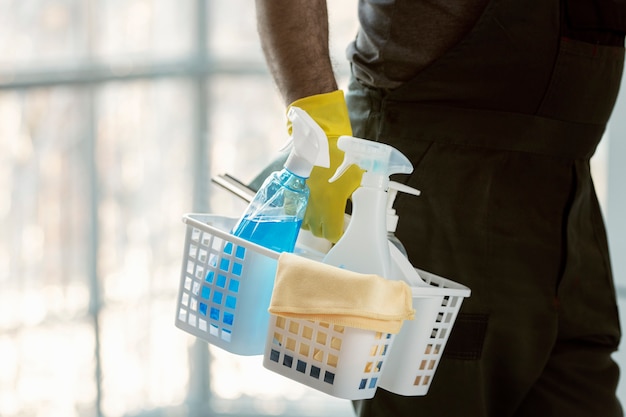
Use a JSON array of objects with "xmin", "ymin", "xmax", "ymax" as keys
[{"xmin": 347, "ymin": 0, "xmax": 489, "ymax": 88}]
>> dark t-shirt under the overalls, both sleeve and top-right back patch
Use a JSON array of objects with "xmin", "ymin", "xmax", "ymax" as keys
[{"xmin": 347, "ymin": 0, "xmax": 626, "ymax": 89}]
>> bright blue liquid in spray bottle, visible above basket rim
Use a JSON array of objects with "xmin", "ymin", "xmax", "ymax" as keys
[{"xmin": 233, "ymin": 216, "xmax": 302, "ymax": 252}]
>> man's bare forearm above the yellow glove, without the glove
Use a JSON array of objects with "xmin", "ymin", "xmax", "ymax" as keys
[{"xmin": 256, "ymin": 0, "xmax": 337, "ymax": 105}]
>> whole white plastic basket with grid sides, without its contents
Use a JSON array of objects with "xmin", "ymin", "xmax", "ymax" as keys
[{"xmin": 175, "ymin": 214, "xmax": 470, "ymax": 399}]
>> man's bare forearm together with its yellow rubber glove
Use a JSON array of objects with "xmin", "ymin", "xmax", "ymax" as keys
[{"xmin": 256, "ymin": 0, "xmax": 361, "ymax": 242}]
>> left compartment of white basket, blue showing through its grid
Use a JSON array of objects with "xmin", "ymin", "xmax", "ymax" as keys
[{"xmin": 175, "ymin": 214, "xmax": 278, "ymax": 355}]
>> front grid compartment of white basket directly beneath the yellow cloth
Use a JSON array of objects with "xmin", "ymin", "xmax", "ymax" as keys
[{"xmin": 263, "ymin": 315, "xmax": 394, "ymax": 399}]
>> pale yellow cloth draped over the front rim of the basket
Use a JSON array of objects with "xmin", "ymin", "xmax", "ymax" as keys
[{"xmin": 269, "ymin": 252, "xmax": 415, "ymax": 334}]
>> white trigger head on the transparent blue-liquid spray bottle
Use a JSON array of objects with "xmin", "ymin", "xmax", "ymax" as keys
[{"xmin": 283, "ymin": 107, "xmax": 330, "ymax": 178}]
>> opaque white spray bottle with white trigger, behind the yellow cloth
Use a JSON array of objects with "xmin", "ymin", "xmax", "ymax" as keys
[{"xmin": 323, "ymin": 136, "xmax": 413, "ymax": 278}]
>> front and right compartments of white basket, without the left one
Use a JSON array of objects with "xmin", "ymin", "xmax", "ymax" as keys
[{"xmin": 263, "ymin": 245, "xmax": 470, "ymax": 400}]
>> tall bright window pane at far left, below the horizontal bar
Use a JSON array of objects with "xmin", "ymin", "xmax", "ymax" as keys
[{"xmin": 0, "ymin": 88, "xmax": 96, "ymax": 416}]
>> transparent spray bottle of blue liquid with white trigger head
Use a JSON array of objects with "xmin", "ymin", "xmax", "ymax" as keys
[{"xmin": 232, "ymin": 107, "xmax": 330, "ymax": 252}]
